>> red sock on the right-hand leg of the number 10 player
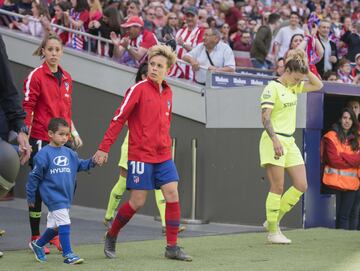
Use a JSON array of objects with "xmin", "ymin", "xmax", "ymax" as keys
[{"xmin": 165, "ymin": 201, "xmax": 180, "ymax": 249}]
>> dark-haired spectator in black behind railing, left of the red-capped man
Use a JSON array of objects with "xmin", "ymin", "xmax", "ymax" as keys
[{"xmin": 89, "ymin": 6, "xmax": 120, "ymax": 57}]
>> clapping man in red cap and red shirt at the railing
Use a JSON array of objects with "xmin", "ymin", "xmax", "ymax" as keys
[{"xmin": 110, "ymin": 16, "xmax": 157, "ymax": 67}]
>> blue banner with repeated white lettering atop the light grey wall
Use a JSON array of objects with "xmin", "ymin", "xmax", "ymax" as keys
[{"xmin": 211, "ymin": 73, "xmax": 273, "ymax": 87}]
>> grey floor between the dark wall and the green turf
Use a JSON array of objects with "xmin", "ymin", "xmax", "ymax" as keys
[{"xmin": 0, "ymin": 198, "xmax": 263, "ymax": 250}]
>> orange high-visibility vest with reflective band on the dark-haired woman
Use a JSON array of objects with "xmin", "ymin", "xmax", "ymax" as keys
[{"xmin": 322, "ymin": 131, "xmax": 360, "ymax": 190}]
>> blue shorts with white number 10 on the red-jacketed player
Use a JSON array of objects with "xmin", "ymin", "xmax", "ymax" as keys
[{"xmin": 126, "ymin": 159, "xmax": 179, "ymax": 190}]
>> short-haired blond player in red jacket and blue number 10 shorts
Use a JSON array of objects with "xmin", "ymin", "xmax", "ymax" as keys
[{"xmin": 94, "ymin": 45, "xmax": 192, "ymax": 261}]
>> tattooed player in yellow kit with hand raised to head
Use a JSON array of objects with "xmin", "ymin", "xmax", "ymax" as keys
[{"xmin": 259, "ymin": 49, "xmax": 323, "ymax": 244}]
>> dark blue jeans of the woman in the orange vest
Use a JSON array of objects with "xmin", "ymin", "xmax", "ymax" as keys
[{"xmin": 335, "ymin": 190, "xmax": 357, "ymax": 230}]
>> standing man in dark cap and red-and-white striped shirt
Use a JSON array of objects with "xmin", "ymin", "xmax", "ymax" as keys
[{"xmin": 169, "ymin": 6, "xmax": 204, "ymax": 80}]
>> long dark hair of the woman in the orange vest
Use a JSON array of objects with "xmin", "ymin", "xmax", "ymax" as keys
[{"xmin": 332, "ymin": 107, "xmax": 359, "ymax": 151}]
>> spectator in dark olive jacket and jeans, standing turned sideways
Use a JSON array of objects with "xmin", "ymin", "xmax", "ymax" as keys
[{"xmin": 250, "ymin": 13, "xmax": 280, "ymax": 69}]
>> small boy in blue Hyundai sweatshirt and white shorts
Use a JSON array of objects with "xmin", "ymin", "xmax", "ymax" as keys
[{"xmin": 26, "ymin": 118, "xmax": 95, "ymax": 264}]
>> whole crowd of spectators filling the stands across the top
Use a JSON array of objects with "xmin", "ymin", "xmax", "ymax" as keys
[{"xmin": 0, "ymin": 0, "xmax": 360, "ymax": 84}]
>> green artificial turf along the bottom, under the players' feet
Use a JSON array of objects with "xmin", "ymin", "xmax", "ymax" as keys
[{"xmin": 0, "ymin": 228, "xmax": 360, "ymax": 271}]
